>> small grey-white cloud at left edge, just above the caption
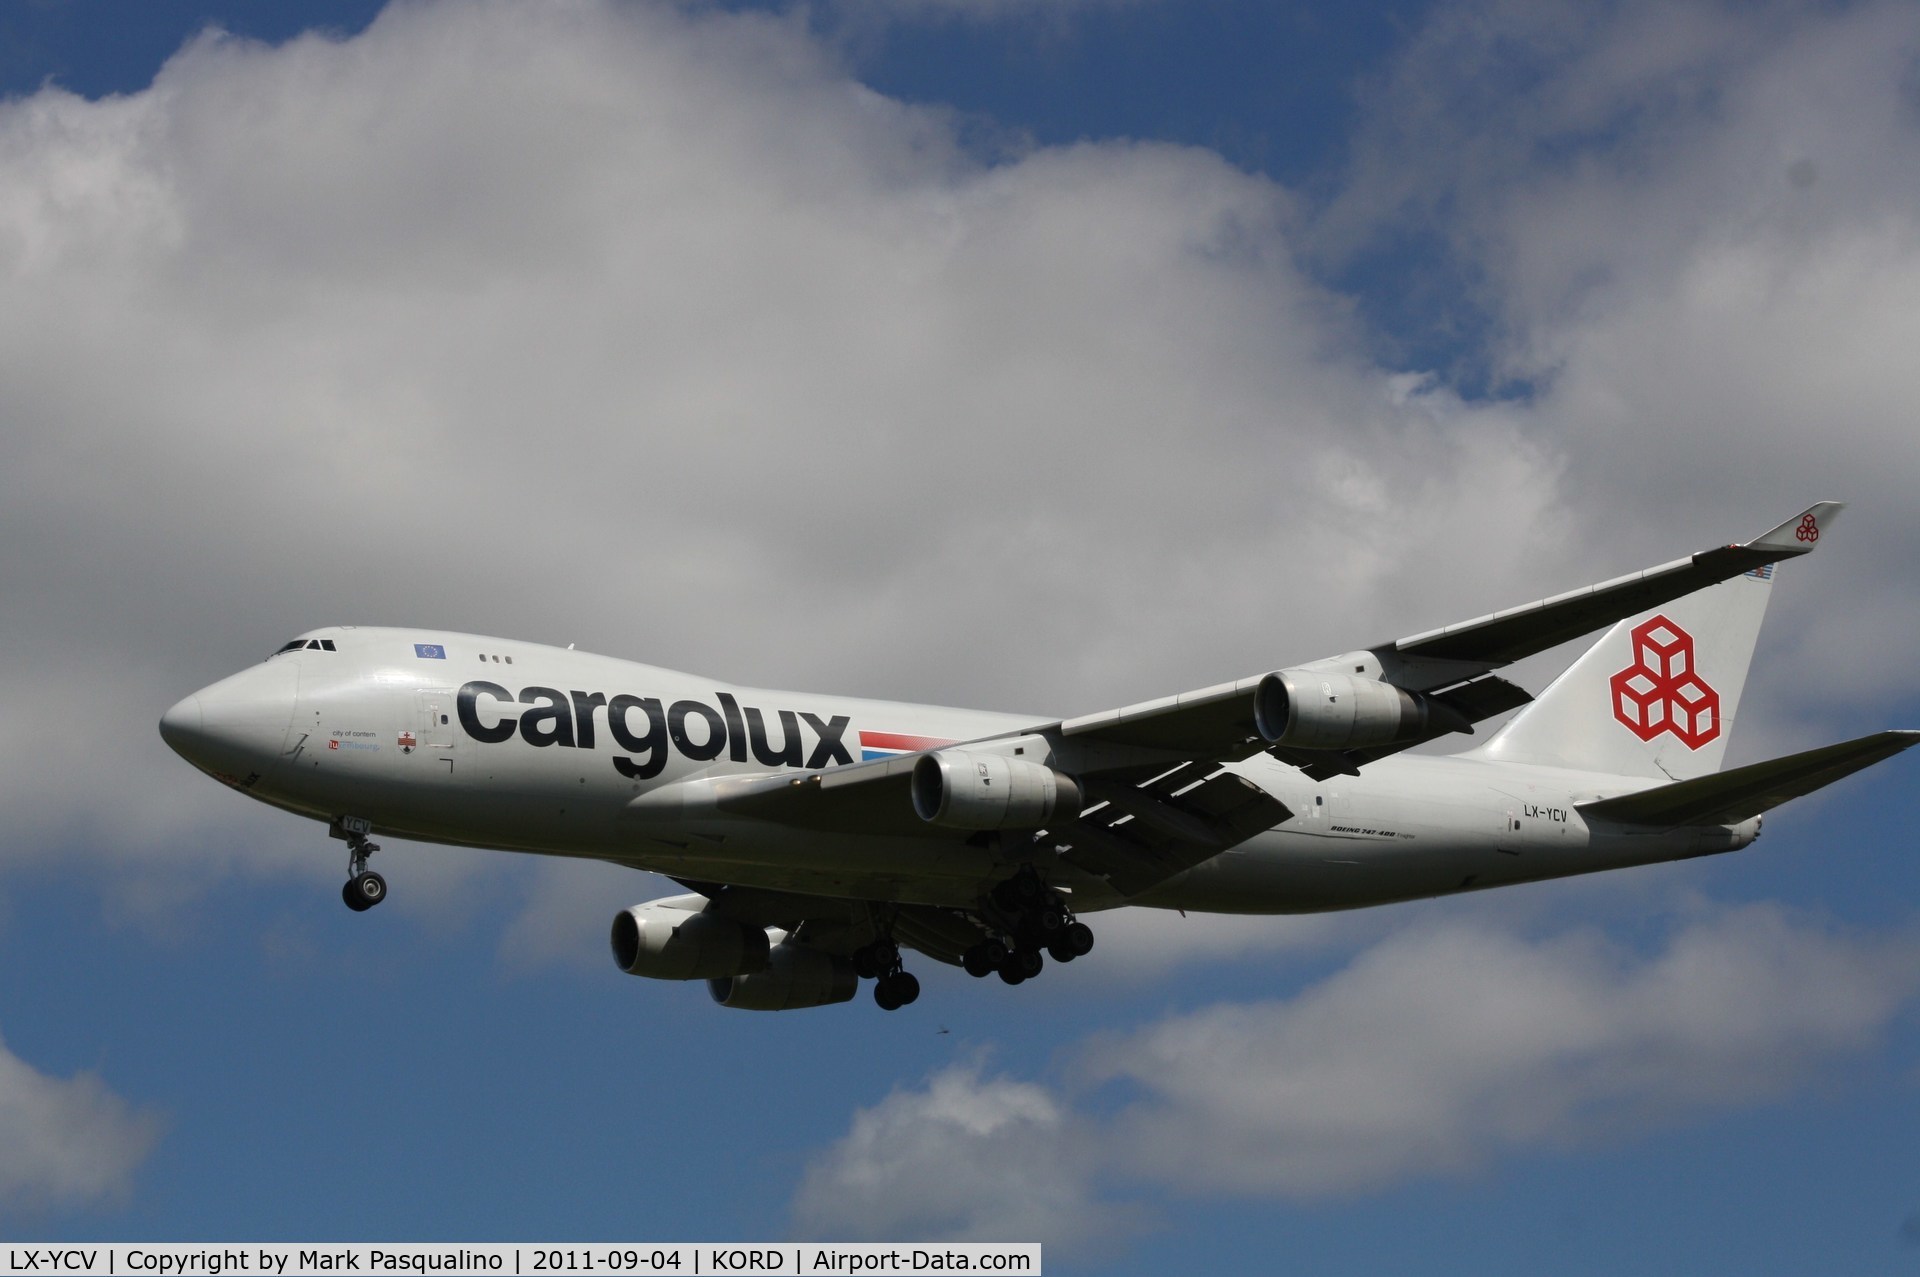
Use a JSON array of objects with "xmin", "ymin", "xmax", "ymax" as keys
[{"xmin": 0, "ymin": 1043, "xmax": 161, "ymax": 1214}]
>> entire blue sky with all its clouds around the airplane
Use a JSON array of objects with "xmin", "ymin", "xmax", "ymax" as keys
[{"xmin": 0, "ymin": 0, "xmax": 1920, "ymax": 1273}]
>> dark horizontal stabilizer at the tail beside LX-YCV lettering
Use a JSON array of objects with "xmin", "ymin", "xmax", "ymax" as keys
[{"xmin": 1580, "ymin": 732, "xmax": 1920, "ymax": 828}]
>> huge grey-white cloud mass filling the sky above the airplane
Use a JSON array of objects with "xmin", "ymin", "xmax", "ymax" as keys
[{"xmin": 0, "ymin": 0, "xmax": 1920, "ymax": 937}]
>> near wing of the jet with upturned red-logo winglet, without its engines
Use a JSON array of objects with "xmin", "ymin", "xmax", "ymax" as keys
[{"xmin": 628, "ymin": 501, "xmax": 1827, "ymax": 895}]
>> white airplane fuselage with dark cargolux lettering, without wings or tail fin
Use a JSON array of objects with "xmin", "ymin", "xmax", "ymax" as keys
[{"xmin": 163, "ymin": 628, "xmax": 1759, "ymax": 914}]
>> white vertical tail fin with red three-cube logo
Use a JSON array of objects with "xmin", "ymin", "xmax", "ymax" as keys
[{"xmin": 1473, "ymin": 565, "xmax": 1774, "ymax": 780}]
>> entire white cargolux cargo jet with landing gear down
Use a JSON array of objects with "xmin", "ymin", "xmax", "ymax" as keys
[{"xmin": 159, "ymin": 501, "xmax": 1920, "ymax": 1010}]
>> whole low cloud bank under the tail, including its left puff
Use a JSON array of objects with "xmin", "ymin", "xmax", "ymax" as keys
[{"xmin": 797, "ymin": 906, "xmax": 1920, "ymax": 1248}]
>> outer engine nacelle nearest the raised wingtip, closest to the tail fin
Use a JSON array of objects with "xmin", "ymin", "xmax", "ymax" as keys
[{"xmin": 1254, "ymin": 670, "xmax": 1443, "ymax": 749}]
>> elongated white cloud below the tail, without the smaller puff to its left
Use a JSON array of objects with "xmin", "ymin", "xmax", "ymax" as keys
[{"xmin": 1085, "ymin": 906, "xmax": 1920, "ymax": 1196}]
